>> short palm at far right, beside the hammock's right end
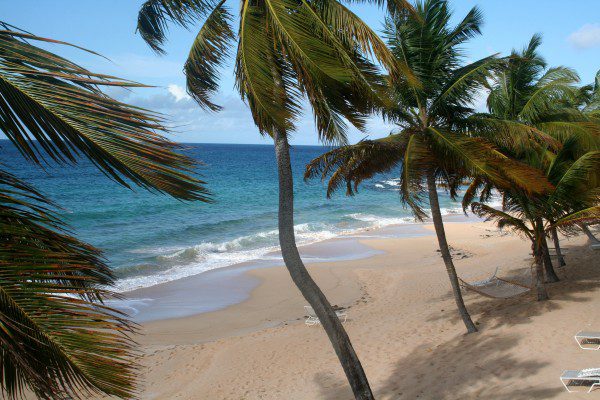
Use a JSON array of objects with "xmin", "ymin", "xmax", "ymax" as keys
[{"xmin": 463, "ymin": 137, "xmax": 600, "ymax": 301}]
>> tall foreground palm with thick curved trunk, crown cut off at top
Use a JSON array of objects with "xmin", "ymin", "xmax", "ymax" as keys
[{"xmin": 138, "ymin": 0, "xmax": 417, "ymax": 399}]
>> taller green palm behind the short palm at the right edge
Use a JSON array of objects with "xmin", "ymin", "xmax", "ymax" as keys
[{"xmin": 474, "ymin": 35, "xmax": 600, "ymax": 282}]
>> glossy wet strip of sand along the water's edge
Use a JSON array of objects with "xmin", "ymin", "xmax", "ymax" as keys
[{"xmin": 119, "ymin": 214, "xmax": 481, "ymax": 323}]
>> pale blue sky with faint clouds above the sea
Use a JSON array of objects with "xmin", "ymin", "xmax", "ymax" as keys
[{"xmin": 0, "ymin": 0, "xmax": 600, "ymax": 145}]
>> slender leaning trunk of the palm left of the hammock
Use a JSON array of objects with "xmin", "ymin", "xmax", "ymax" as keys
[{"xmin": 427, "ymin": 172, "xmax": 477, "ymax": 333}]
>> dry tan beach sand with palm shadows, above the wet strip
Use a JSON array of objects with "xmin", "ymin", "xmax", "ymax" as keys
[{"xmin": 134, "ymin": 223, "xmax": 600, "ymax": 400}]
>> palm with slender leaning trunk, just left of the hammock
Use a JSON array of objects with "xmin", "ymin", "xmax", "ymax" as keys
[{"xmin": 305, "ymin": 0, "xmax": 545, "ymax": 333}]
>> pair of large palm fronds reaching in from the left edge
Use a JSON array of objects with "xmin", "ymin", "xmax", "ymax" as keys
[{"xmin": 0, "ymin": 23, "xmax": 209, "ymax": 399}]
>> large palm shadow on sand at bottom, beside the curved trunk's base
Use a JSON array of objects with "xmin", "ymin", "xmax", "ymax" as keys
[{"xmin": 315, "ymin": 335, "xmax": 562, "ymax": 400}]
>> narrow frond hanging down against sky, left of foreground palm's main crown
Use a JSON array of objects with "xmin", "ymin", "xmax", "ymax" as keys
[{"xmin": 183, "ymin": 0, "xmax": 235, "ymax": 111}]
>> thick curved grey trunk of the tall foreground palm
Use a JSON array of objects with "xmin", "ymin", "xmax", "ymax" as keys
[{"xmin": 274, "ymin": 133, "xmax": 374, "ymax": 400}]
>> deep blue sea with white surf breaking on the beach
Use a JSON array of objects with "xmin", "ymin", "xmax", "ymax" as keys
[{"xmin": 0, "ymin": 140, "xmax": 474, "ymax": 291}]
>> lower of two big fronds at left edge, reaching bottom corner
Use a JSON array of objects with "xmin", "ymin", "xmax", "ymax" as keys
[{"xmin": 0, "ymin": 171, "xmax": 137, "ymax": 399}]
